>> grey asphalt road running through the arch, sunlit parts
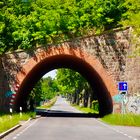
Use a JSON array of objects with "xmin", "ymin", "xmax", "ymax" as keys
[{"xmin": 4, "ymin": 97, "xmax": 140, "ymax": 140}]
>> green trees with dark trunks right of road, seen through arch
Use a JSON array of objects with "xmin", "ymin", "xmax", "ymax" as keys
[{"xmin": 56, "ymin": 69, "xmax": 93, "ymax": 107}]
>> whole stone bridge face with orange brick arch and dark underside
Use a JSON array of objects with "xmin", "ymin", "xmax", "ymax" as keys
[{"xmin": 0, "ymin": 28, "xmax": 139, "ymax": 115}]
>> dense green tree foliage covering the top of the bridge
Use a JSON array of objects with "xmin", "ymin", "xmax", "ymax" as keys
[{"xmin": 0, "ymin": 0, "xmax": 126, "ymax": 53}]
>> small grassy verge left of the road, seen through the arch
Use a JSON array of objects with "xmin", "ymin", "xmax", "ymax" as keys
[{"xmin": 37, "ymin": 97, "xmax": 57, "ymax": 109}]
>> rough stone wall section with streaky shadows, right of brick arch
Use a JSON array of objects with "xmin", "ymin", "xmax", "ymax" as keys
[{"xmin": 81, "ymin": 29, "xmax": 130, "ymax": 86}]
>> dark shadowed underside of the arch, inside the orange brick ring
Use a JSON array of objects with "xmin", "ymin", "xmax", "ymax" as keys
[{"xmin": 15, "ymin": 54, "xmax": 113, "ymax": 116}]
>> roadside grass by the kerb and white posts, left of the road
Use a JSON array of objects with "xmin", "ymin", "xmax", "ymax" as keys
[{"xmin": 0, "ymin": 112, "xmax": 35, "ymax": 133}]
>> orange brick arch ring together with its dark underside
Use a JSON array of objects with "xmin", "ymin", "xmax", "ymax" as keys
[{"xmin": 15, "ymin": 46, "xmax": 117, "ymax": 113}]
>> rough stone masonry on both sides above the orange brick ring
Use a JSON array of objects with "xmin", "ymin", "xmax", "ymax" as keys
[{"xmin": 3, "ymin": 28, "xmax": 130, "ymax": 93}]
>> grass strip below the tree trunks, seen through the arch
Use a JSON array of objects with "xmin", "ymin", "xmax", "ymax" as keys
[{"xmin": 72, "ymin": 104, "xmax": 98, "ymax": 114}]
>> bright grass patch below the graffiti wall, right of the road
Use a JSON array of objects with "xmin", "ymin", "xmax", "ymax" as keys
[{"xmin": 101, "ymin": 114, "xmax": 140, "ymax": 126}]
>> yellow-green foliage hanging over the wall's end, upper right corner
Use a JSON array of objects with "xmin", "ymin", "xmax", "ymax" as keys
[{"xmin": 121, "ymin": 0, "xmax": 140, "ymax": 56}]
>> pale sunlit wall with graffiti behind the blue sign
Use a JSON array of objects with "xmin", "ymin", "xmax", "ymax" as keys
[{"xmin": 114, "ymin": 28, "xmax": 140, "ymax": 114}]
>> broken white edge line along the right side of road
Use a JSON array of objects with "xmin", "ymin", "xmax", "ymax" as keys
[{"xmin": 95, "ymin": 119, "xmax": 138, "ymax": 140}]
